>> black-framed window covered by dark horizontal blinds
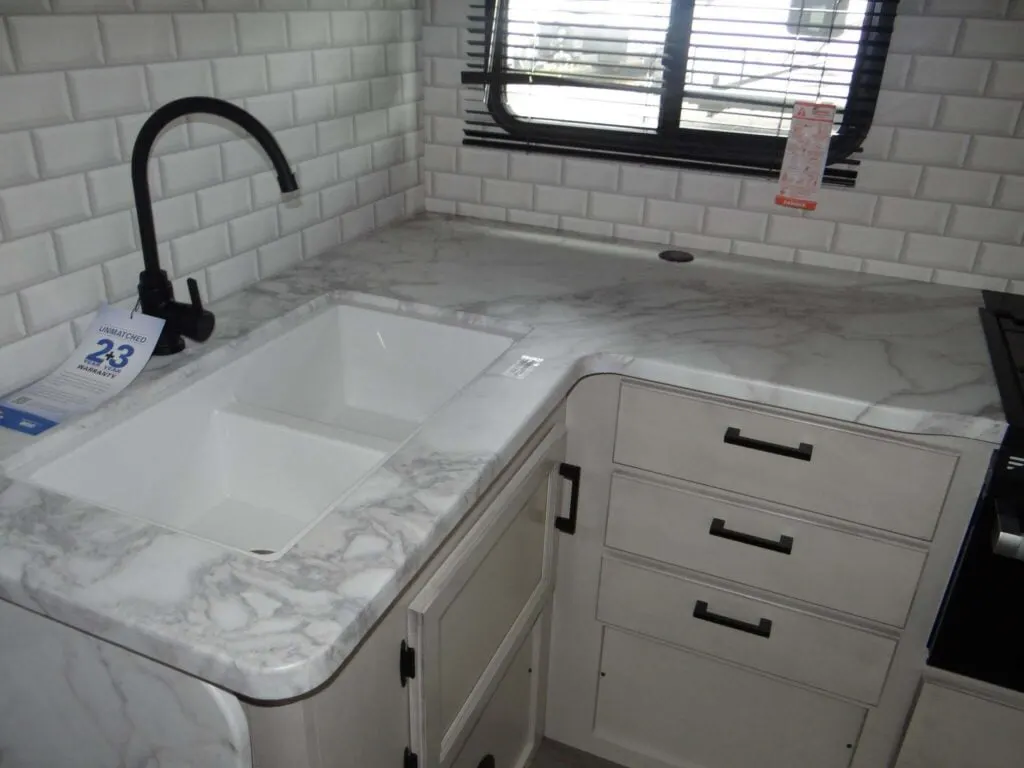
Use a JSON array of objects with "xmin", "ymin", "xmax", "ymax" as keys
[{"xmin": 463, "ymin": 0, "xmax": 896, "ymax": 184}]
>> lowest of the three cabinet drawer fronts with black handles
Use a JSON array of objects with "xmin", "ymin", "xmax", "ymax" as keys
[{"xmin": 597, "ymin": 557, "xmax": 896, "ymax": 703}]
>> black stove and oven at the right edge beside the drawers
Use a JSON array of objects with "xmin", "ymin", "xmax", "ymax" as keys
[{"xmin": 928, "ymin": 291, "xmax": 1024, "ymax": 692}]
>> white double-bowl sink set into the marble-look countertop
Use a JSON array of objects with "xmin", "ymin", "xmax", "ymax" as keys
[{"xmin": 22, "ymin": 304, "xmax": 514, "ymax": 559}]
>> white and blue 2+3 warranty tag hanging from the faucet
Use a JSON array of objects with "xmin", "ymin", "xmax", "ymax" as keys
[{"xmin": 0, "ymin": 306, "xmax": 164, "ymax": 434}]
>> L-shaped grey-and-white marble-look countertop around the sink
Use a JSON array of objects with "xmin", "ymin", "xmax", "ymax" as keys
[{"xmin": 0, "ymin": 218, "xmax": 1006, "ymax": 699}]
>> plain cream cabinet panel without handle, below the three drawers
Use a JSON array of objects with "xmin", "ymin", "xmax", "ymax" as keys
[{"xmin": 595, "ymin": 629, "xmax": 865, "ymax": 768}]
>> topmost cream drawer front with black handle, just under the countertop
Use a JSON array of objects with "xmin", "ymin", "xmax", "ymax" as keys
[{"xmin": 615, "ymin": 384, "xmax": 956, "ymax": 540}]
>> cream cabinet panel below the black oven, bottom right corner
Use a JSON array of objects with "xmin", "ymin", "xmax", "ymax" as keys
[{"xmin": 896, "ymin": 683, "xmax": 1024, "ymax": 768}]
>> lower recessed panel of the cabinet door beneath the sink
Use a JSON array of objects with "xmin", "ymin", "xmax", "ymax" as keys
[{"xmin": 454, "ymin": 626, "xmax": 536, "ymax": 768}]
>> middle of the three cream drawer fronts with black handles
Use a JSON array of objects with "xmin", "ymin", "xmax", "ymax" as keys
[{"xmin": 606, "ymin": 473, "xmax": 925, "ymax": 627}]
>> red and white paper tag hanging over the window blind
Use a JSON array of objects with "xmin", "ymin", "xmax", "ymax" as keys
[{"xmin": 775, "ymin": 101, "xmax": 836, "ymax": 211}]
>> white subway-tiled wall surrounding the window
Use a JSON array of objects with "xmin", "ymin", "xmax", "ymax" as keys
[{"xmin": 423, "ymin": 0, "xmax": 1024, "ymax": 292}]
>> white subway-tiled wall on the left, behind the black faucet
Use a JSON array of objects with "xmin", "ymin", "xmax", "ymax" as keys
[{"xmin": 0, "ymin": 0, "xmax": 423, "ymax": 394}]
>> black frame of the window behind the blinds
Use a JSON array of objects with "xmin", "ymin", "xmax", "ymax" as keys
[{"xmin": 463, "ymin": 0, "xmax": 898, "ymax": 184}]
